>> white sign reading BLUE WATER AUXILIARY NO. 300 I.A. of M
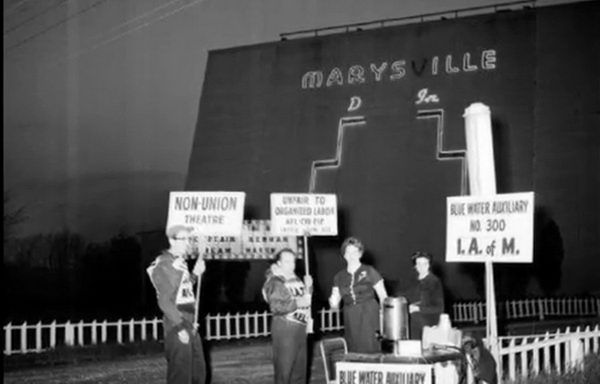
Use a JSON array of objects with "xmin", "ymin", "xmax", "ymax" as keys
[{"xmin": 446, "ymin": 192, "xmax": 534, "ymax": 263}]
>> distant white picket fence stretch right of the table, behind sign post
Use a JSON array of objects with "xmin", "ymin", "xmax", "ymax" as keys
[{"xmin": 452, "ymin": 297, "xmax": 600, "ymax": 324}]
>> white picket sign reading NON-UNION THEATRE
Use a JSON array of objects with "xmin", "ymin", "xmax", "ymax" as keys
[{"xmin": 167, "ymin": 191, "xmax": 246, "ymax": 236}]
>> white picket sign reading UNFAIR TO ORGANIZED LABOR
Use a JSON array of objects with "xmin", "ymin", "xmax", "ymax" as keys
[{"xmin": 271, "ymin": 193, "xmax": 337, "ymax": 236}]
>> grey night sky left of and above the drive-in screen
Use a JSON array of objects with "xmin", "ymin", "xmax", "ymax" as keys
[{"xmin": 4, "ymin": 0, "xmax": 580, "ymax": 241}]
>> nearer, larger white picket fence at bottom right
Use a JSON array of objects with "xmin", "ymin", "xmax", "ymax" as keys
[{"xmin": 499, "ymin": 325, "xmax": 600, "ymax": 381}]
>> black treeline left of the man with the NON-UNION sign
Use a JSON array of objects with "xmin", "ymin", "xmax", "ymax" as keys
[{"xmin": 3, "ymin": 230, "xmax": 148, "ymax": 321}]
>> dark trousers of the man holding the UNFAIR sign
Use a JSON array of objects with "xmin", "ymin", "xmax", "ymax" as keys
[{"xmin": 271, "ymin": 316, "xmax": 307, "ymax": 384}]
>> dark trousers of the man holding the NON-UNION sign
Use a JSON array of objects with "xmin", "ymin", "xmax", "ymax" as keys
[{"xmin": 165, "ymin": 329, "xmax": 206, "ymax": 384}]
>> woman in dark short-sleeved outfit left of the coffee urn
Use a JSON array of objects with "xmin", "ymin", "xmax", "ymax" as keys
[{"xmin": 329, "ymin": 237, "xmax": 387, "ymax": 353}]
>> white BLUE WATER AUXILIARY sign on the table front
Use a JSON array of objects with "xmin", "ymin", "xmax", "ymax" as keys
[{"xmin": 335, "ymin": 362, "xmax": 432, "ymax": 384}]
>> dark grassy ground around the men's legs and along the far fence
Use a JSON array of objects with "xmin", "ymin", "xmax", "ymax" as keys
[{"xmin": 4, "ymin": 318, "xmax": 598, "ymax": 384}]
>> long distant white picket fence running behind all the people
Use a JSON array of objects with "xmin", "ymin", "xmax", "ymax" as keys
[{"xmin": 4, "ymin": 298, "xmax": 600, "ymax": 355}]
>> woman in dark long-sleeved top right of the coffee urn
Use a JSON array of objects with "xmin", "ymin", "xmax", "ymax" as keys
[{"xmin": 408, "ymin": 251, "xmax": 444, "ymax": 340}]
